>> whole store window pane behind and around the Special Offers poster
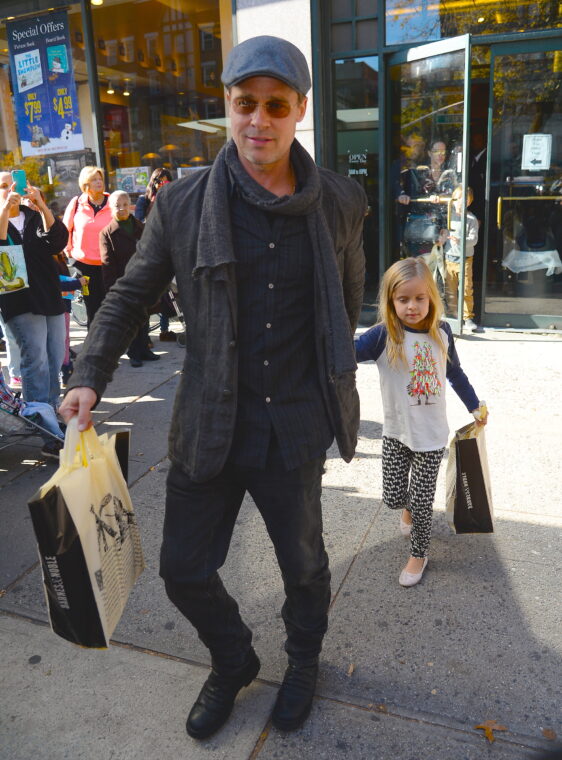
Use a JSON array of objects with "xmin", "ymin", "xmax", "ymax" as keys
[{"xmin": 0, "ymin": 3, "xmax": 96, "ymax": 213}]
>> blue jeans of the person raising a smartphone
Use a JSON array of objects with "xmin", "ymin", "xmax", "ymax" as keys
[{"xmin": 8, "ymin": 312, "xmax": 49, "ymax": 404}]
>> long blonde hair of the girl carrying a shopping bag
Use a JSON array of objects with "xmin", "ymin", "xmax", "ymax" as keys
[{"xmin": 379, "ymin": 257, "xmax": 447, "ymax": 366}]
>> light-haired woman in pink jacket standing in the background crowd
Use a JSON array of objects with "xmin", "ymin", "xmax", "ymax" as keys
[{"xmin": 63, "ymin": 166, "xmax": 111, "ymax": 327}]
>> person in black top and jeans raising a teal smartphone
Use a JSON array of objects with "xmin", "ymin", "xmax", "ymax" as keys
[{"xmin": 0, "ymin": 171, "xmax": 68, "ymax": 458}]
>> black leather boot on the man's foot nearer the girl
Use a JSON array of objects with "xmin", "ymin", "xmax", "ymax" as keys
[{"xmin": 271, "ymin": 663, "xmax": 318, "ymax": 731}]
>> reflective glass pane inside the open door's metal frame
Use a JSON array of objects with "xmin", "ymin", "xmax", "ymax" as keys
[{"xmin": 389, "ymin": 51, "xmax": 464, "ymax": 316}]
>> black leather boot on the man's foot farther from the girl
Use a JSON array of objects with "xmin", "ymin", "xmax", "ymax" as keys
[{"xmin": 185, "ymin": 649, "xmax": 260, "ymax": 739}]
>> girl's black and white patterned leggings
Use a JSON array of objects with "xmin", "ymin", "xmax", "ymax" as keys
[{"xmin": 382, "ymin": 436, "xmax": 445, "ymax": 557}]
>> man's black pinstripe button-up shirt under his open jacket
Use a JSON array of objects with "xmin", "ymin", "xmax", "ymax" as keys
[{"xmin": 226, "ymin": 192, "xmax": 334, "ymax": 470}]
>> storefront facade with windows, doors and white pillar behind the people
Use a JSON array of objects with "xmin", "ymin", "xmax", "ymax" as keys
[{"xmin": 0, "ymin": 0, "xmax": 562, "ymax": 331}]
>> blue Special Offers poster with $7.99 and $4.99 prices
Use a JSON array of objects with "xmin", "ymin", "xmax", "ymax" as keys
[{"xmin": 6, "ymin": 11, "xmax": 84, "ymax": 156}]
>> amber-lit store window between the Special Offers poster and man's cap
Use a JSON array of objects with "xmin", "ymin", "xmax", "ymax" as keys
[{"xmin": 92, "ymin": 0, "xmax": 226, "ymax": 197}]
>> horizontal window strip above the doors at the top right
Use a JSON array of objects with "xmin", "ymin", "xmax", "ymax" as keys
[{"xmin": 385, "ymin": 0, "xmax": 562, "ymax": 45}]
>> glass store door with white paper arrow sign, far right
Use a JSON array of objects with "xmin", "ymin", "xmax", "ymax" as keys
[{"xmin": 483, "ymin": 39, "xmax": 562, "ymax": 329}]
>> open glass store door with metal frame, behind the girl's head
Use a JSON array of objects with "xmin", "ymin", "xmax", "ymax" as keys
[{"xmin": 386, "ymin": 35, "xmax": 473, "ymax": 332}]
